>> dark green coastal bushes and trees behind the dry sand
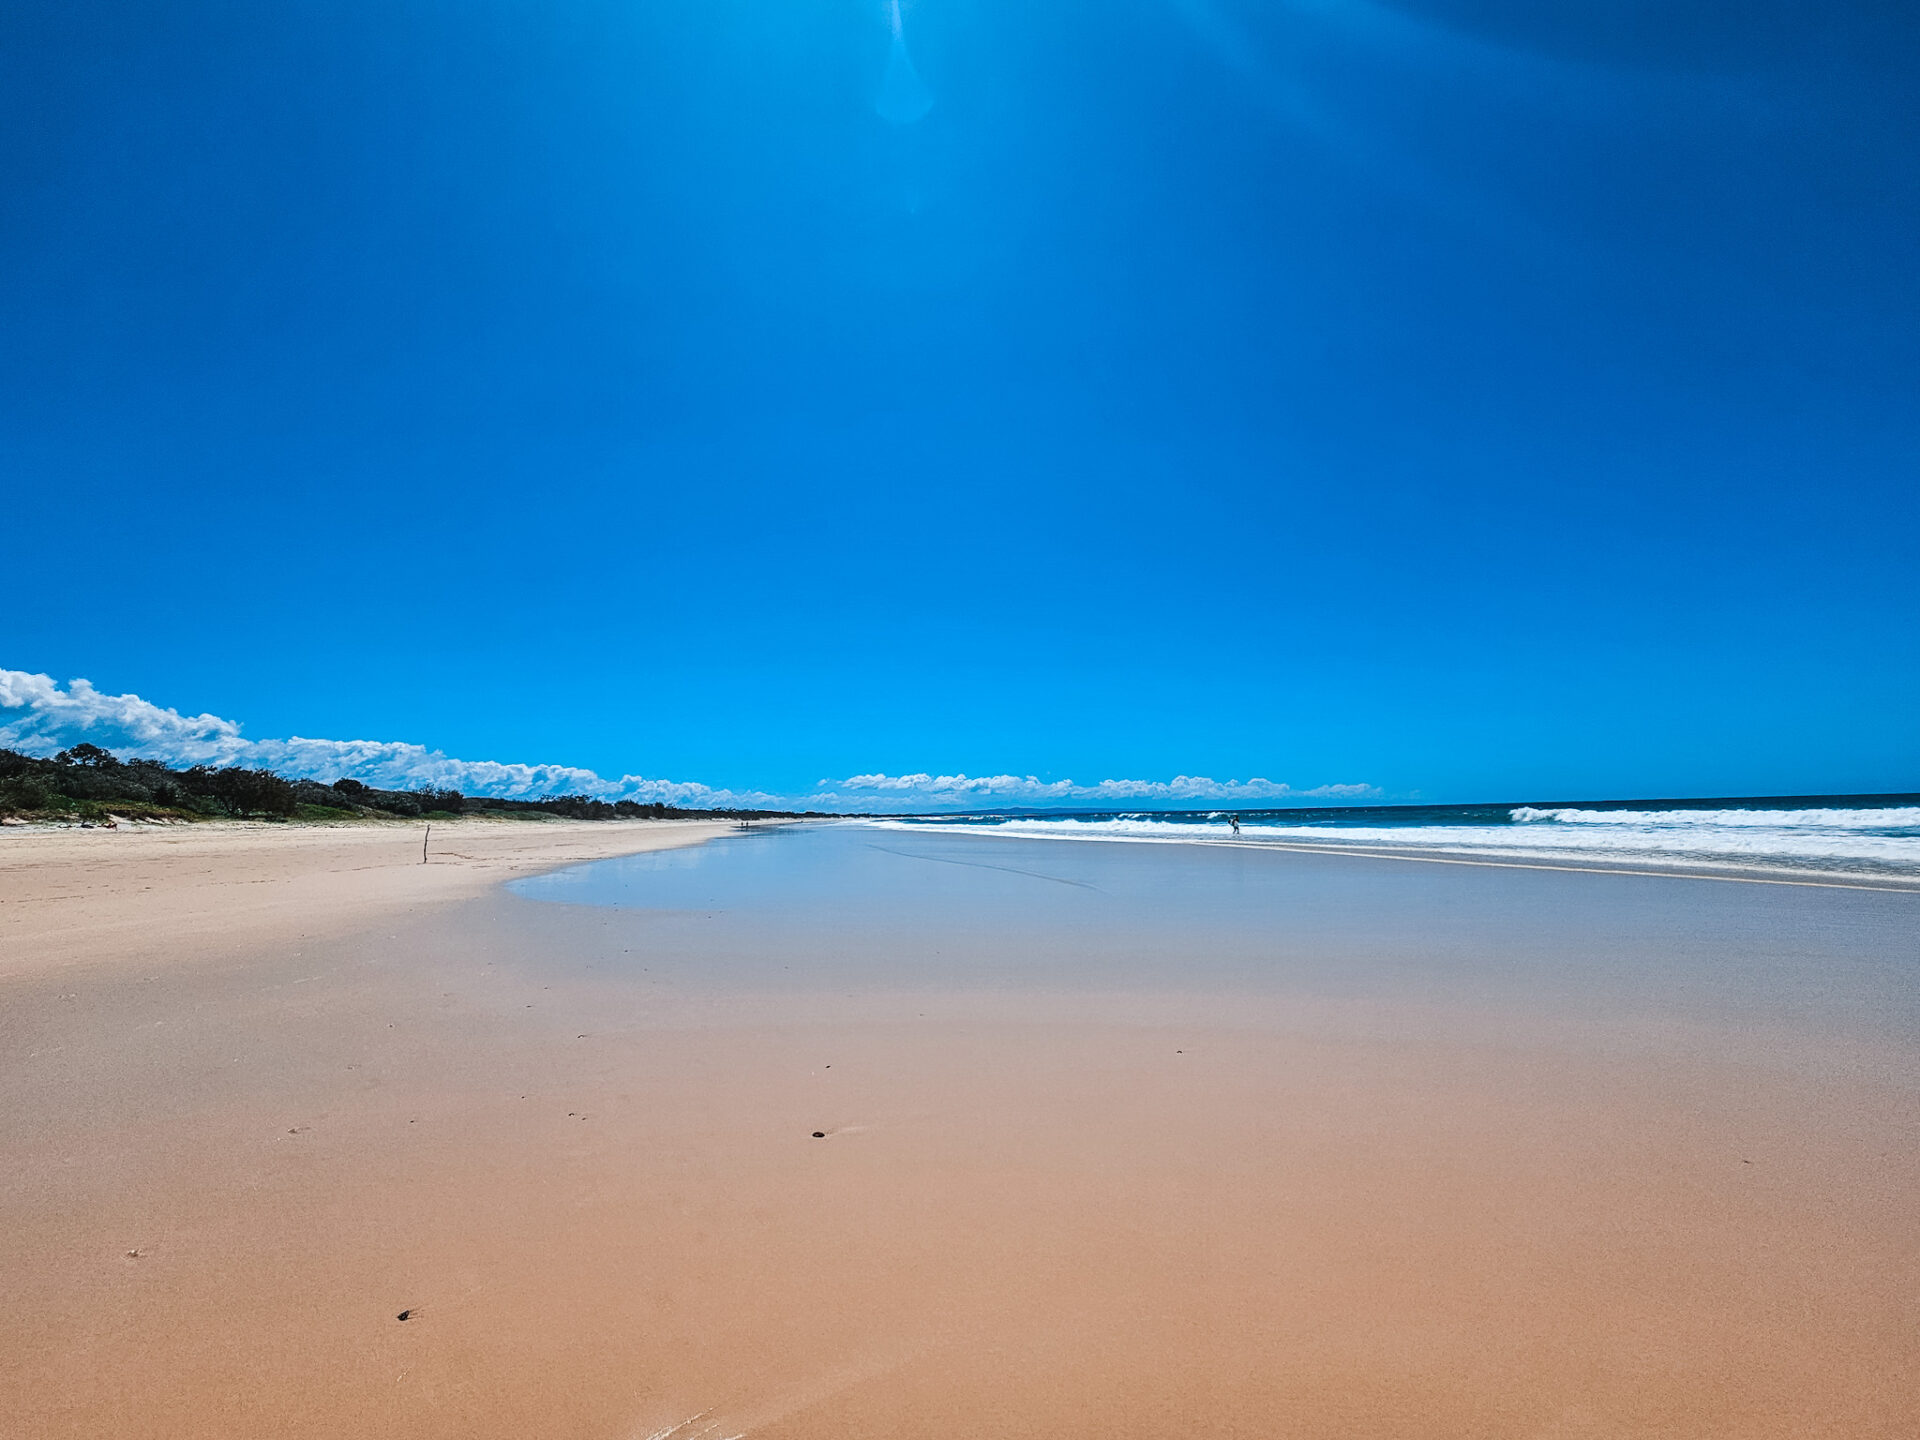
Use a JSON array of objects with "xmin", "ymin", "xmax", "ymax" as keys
[{"xmin": 0, "ymin": 745, "xmax": 802, "ymax": 822}]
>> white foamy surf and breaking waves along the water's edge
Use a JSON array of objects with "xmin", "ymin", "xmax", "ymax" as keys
[{"xmin": 867, "ymin": 806, "xmax": 1920, "ymax": 879}]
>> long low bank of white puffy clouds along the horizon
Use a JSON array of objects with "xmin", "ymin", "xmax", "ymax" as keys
[{"xmin": 0, "ymin": 670, "xmax": 1379, "ymax": 812}]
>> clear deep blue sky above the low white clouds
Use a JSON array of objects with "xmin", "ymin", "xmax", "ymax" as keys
[{"xmin": 0, "ymin": 0, "xmax": 1920, "ymax": 799}]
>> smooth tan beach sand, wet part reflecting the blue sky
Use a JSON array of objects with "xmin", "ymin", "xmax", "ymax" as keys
[{"xmin": 0, "ymin": 828, "xmax": 1920, "ymax": 1440}]
